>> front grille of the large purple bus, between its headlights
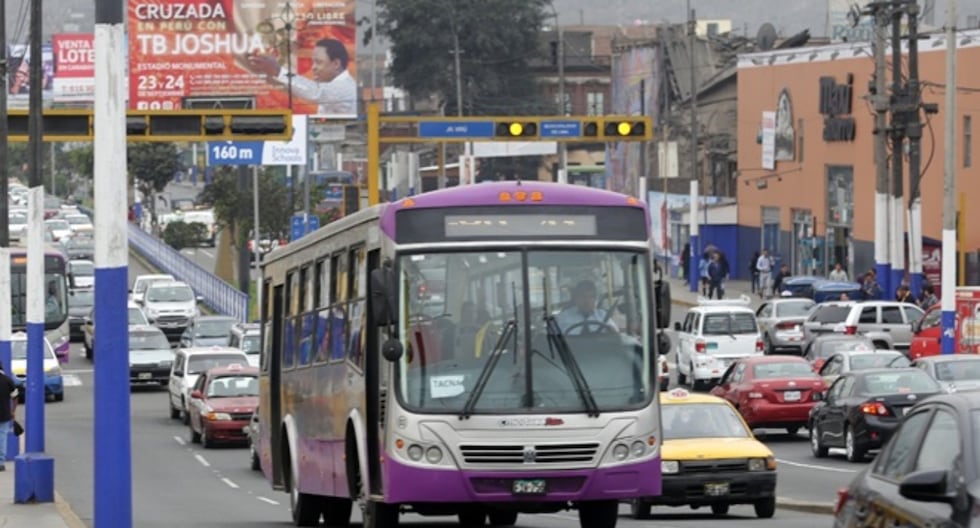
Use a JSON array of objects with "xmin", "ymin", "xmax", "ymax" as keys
[{"xmin": 459, "ymin": 442, "xmax": 599, "ymax": 465}]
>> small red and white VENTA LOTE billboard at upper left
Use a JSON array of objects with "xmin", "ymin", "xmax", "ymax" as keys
[{"xmin": 51, "ymin": 33, "xmax": 95, "ymax": 103}]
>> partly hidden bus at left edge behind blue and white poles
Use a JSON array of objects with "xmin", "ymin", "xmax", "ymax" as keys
[{"xmin": 10, "ymin": 247, "xmax": 70, "ymax": 363}]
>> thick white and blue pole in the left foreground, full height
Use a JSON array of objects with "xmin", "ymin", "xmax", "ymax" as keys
[{"xmin": 93, "ymin": 0, "xmax": 133, "ymax": 528}]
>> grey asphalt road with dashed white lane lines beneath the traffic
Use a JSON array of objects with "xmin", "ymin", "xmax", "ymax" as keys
[{"xmin": 40, "ymin": 261, "xmax": 836, "ymax": 528}]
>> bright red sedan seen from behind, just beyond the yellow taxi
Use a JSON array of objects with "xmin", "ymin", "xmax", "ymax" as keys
[{"xmin": 711, "ymin": 356, "xmax": 827, "ymax": 435}]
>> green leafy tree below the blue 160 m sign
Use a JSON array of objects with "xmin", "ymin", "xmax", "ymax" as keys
[{"xmin": 198, "ymin": 167, "xmax": 290, "ymax": 247}]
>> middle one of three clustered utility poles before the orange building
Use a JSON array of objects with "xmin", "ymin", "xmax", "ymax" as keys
[{"xmin": 881, "ymin": 5, "xmax": 905, "ymax": 299}]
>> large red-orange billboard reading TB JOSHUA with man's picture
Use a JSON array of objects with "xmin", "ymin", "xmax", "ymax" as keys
[{"xmin": 128, "ymin": 0, "xmax": 358, "ymax": 117}]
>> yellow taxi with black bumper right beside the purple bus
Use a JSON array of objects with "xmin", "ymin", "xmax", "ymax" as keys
[{"xmin": 630, "ymin": 389, "xmax": 776, "ymax": 519}]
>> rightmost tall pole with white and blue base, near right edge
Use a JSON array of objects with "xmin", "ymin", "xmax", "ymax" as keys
[{"xmin": 941, "ymin": 0, "xmax": 965, "ymax": 354}]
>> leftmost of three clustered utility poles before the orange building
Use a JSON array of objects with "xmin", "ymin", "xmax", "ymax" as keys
[{"xmin": 871, "ymin": 2, "xmax": 891, "ymax": 302}]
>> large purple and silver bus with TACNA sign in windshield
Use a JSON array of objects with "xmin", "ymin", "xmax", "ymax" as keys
[{"xmin": 256, "ymin": 181, "xmax": 670, "ymax": 528}]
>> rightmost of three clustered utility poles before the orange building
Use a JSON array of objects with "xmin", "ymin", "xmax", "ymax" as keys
[{"xmin": 905, "ymin": 2, "xmax": 922, "ymax": 295}]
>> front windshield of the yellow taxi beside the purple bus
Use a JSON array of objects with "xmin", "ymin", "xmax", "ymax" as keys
[{"xmin": 663, "ymin": 403, "xmax": 751, "ymax": 440}]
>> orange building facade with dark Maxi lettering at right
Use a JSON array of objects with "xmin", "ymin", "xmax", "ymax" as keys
[{"xmin": 736, "ymin": 30, "xmax": 980, "ymax": 277}]
